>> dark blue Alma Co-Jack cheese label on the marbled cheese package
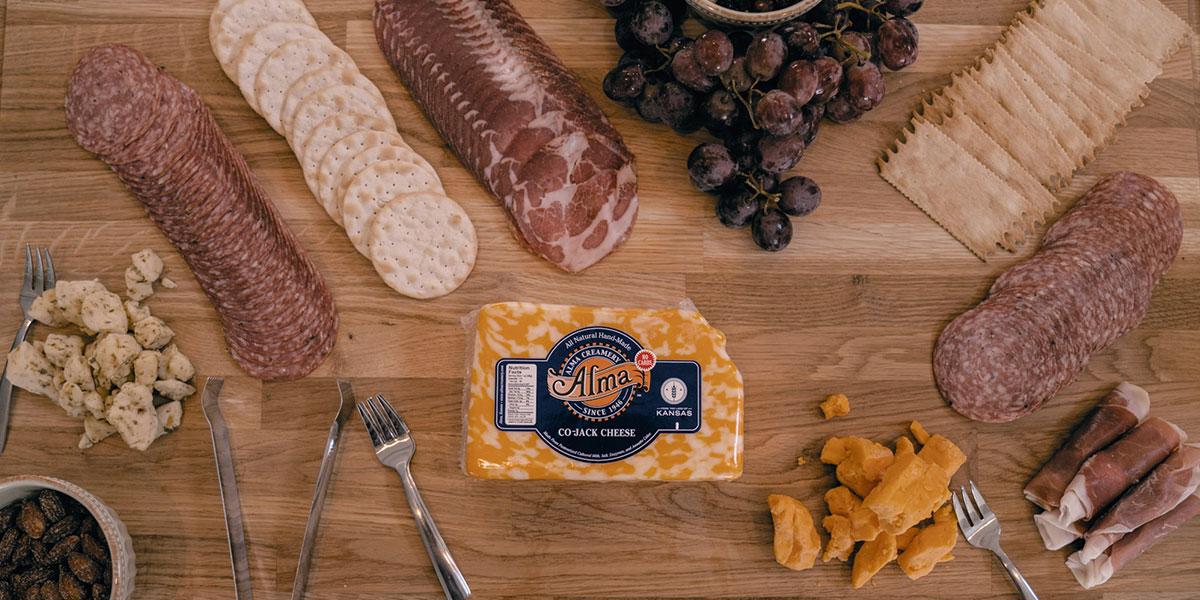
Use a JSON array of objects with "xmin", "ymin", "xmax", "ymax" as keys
[{"xmin": 496, "ymin": 326, "xmax": 703, "ymax": 463}]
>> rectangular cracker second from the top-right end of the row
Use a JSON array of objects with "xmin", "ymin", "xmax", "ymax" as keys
[{"xmin": 1033, "ymin": 0, "xmax": 1163, "ymax": 83}]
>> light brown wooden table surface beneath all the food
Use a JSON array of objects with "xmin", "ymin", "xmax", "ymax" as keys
[{"xmin": 0, "ymin": 0, "xmax": 1200, "ymax": 600}]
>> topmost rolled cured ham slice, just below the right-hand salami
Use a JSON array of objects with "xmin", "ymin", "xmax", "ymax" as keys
[{"xmin": 1025, "ymin": 383, "xmax": 1150, "ymax": 510}]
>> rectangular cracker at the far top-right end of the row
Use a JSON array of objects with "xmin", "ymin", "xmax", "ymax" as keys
[{"xmin": 1072, "ymin": 0, "xmax": 1192, "ymax": 65}]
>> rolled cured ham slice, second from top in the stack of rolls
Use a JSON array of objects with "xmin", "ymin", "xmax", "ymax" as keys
[{"xmin": 1034, "ymin": 416, "xmax": 1187, "ymax": 547}]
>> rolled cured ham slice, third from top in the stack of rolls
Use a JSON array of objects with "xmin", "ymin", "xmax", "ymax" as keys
[{"xmin": 1080, "ymin": 444, "xmax": 1200, "ymax": 562}]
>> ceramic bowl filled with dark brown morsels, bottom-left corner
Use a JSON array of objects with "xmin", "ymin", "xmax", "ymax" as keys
[{"xmin": 0, "ymin": 475, "xmax": 137, "ymax": 600}]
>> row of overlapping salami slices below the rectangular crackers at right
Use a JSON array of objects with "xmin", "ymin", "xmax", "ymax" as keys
[{"xmin": 934, "ymin": 173, "xmax": 1183, "ymax": 422}]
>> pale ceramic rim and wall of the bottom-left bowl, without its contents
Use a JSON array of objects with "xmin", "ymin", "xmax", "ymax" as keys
[{"xmin": 0, "ymin": 475, "xmax": 137, "ymax": 600}]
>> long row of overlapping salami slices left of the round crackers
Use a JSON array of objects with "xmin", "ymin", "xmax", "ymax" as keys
[{"xmin": 66, "ymin": 46, "xmax": 337, "ymax": 379}]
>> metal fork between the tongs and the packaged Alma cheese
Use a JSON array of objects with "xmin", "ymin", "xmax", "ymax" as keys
[{"xmin": 358, "ymin": 394, "xmax": 470, "ymax": 600}]
